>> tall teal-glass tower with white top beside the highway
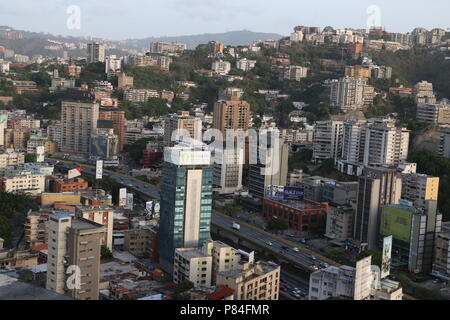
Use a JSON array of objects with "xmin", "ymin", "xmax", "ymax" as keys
[{"xmin": 159, "ymin": 142, "xmax": 213, "ymax": 270}]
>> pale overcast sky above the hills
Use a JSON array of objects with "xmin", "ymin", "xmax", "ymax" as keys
[{"xmin": 0, "ymin": 0, "xmax": 450, "ymax": 40}]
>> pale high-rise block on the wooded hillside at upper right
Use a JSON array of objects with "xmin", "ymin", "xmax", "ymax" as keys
[{"xmin": 330, "ymin": 77, "xmax": 367, "ymax": 113}]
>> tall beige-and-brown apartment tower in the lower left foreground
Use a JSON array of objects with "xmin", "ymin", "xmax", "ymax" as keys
[{"xmin": 46, "ymin": 214, "xmax": 105, "ymax": 300}]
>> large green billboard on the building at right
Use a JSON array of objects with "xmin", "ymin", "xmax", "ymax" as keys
[{"xmin": 380, "ymin": 206, "xmax": 412, "ymax": 243}]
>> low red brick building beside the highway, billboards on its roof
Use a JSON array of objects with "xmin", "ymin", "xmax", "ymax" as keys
[{"xmin": 262, "ymin": 199, "xmax": 328, "ymax": 231}]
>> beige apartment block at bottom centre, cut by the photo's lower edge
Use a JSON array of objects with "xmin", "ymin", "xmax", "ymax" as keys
[{"xmin": 216, "ymin": 261, "xmax": 280, "ymax": 300}]
